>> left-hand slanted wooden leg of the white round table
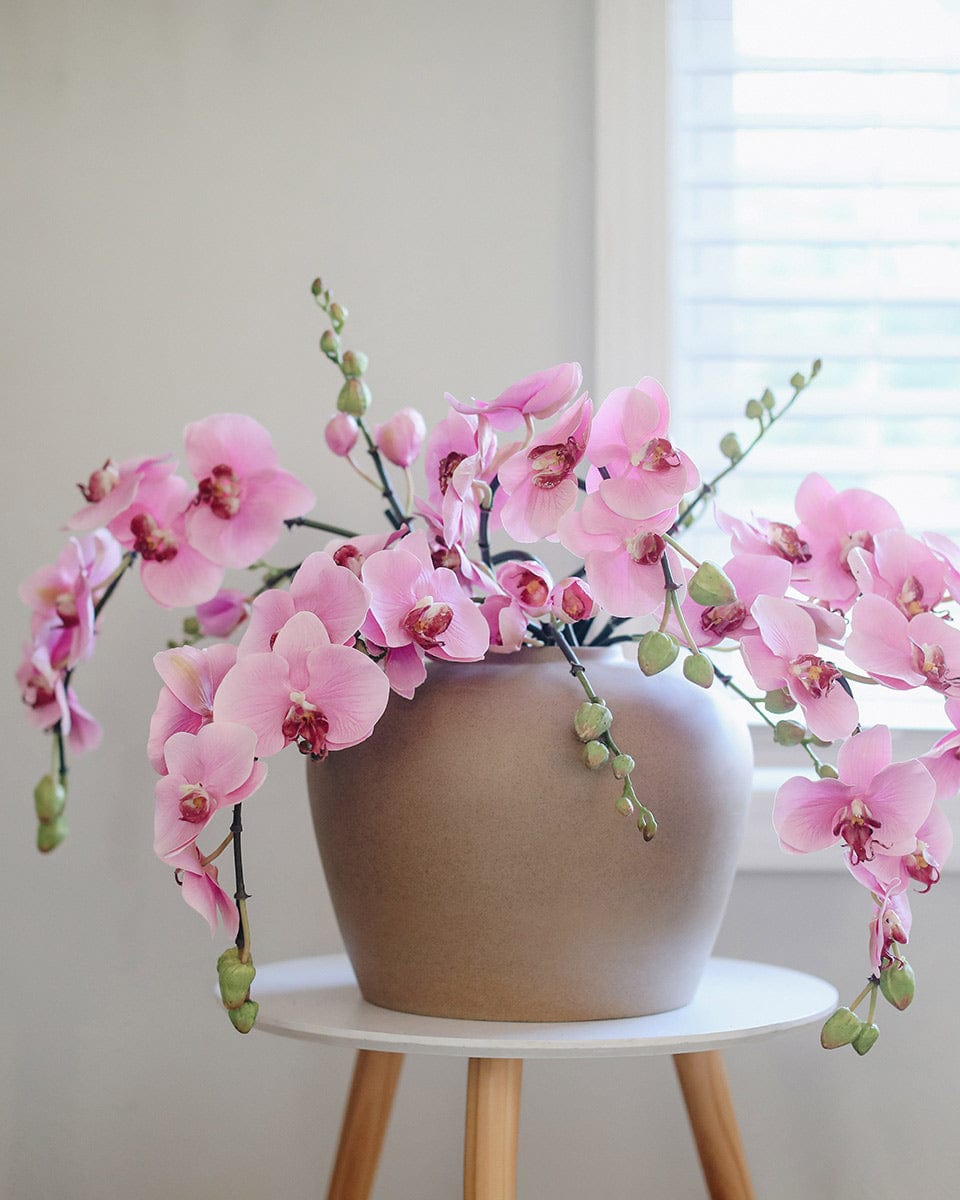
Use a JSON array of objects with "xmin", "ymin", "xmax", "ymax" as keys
[{"xmin": 326, "ymin": 1050, "xmax": 403, "ymax": 1200}]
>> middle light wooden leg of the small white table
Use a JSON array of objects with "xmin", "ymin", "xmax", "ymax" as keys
[{"xmin": 463, "ymin": 1058, "xmax": 523, "ymax": 1200}]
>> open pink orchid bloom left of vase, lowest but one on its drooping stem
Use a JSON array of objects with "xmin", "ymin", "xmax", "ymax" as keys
[{"xmin": 154, "ymin": 721, "xmax": 266, "ymax": 859}]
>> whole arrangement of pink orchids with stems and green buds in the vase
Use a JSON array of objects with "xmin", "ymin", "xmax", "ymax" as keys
[{"xmin": 17, "ymin": 280, "xmax": 960, "ymax": 1054}]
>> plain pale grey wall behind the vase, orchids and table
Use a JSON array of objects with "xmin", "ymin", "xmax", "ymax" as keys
[{"xmin": 0, "ymin": 0, "xmax": 958, "ymax": 1200}]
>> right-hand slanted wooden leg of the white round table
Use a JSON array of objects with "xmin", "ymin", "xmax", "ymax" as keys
[{"xmin": 673, "ymin": 1050, "xmax": 754, "ymax": 1200}]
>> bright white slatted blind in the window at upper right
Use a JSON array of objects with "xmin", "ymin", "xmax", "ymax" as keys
[{"xmin": 668, "ymin": 0, "xmax": 960, "ymax": 536}]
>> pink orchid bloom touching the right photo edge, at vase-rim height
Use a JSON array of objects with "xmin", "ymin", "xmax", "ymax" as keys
[{"xmin": 846, "ymin": 594, "xmax": 960, "ymax": 696}]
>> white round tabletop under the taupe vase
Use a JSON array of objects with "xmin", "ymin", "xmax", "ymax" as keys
[{"xmin": 252, "ymin": 954, "xmax": 838, "ymax": 1058}]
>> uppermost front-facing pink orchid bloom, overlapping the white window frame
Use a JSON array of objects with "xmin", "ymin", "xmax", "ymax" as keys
[{"xmin": 587, "ymin": 378, "xmax": 700, "ymax": 520}]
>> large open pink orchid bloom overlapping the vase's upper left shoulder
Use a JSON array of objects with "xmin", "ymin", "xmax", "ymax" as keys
[{"xmin": 214, "ymin": 609, "xmax": 396, "ymax": 758}]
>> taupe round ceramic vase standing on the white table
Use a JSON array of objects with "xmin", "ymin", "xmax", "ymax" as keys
[{"xmin": 307, "ymin": 647, "xmax": 752, "ymax": 1021}]
